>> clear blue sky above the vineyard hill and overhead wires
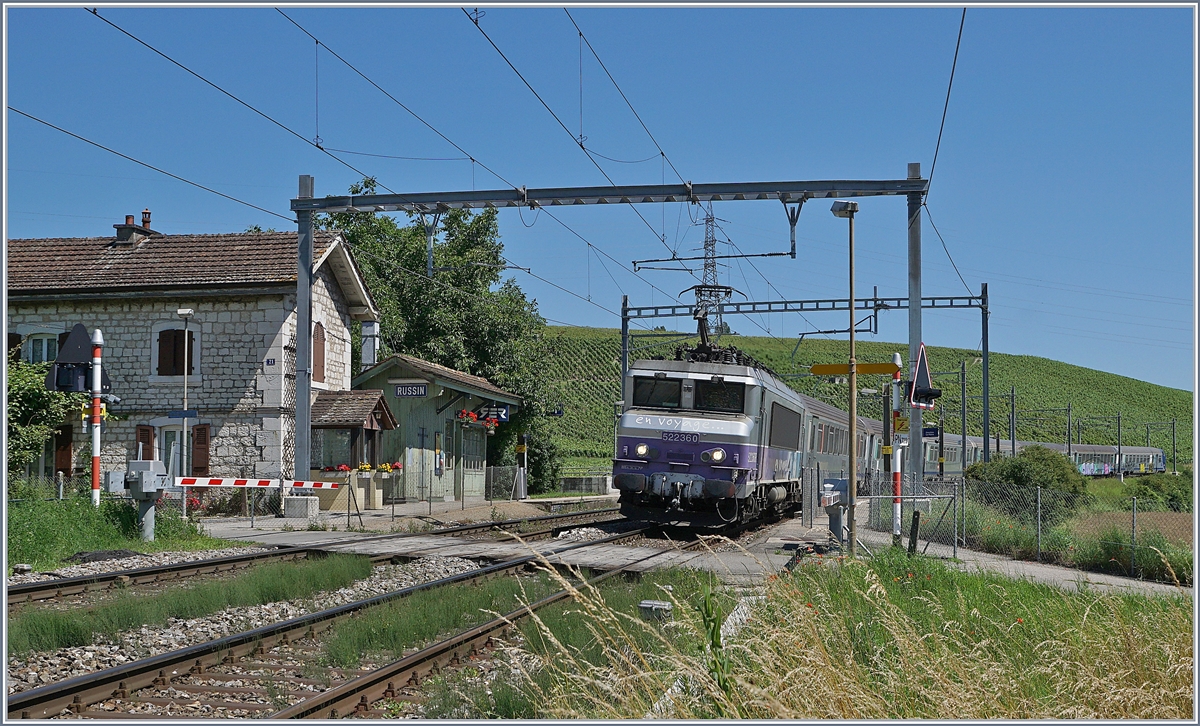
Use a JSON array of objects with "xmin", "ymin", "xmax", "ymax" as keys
[{"xmin": 5, "ymin": 7, "xmax": 1195, "ymax": 390}]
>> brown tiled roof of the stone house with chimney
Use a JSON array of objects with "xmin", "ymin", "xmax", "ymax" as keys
[{"xmin": 8, "ymin": 230, "xmax": 337, "ymax": 295}]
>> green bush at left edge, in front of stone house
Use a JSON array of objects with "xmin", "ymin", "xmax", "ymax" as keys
[{"xmin": 7, "ymin": 355, "xmax": 86, "ymax": 476}]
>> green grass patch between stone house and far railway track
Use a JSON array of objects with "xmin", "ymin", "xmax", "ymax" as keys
[{"xmin": 6, "ymin": 494, "xmax": 236, "ymax": 570}]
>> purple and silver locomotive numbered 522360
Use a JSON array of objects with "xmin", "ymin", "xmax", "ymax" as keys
[{"xmin": 613, "ymin": 336, "xmax": 806, "ymax": 528}]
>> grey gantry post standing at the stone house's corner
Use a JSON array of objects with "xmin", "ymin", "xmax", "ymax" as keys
[{"xmin": 294, "ymin": 174, "xmax": 313, "ymax": 487}]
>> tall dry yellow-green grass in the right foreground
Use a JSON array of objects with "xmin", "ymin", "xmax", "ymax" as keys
[{"xmin": 458, "ymin": 552, "xmax": 1194, "ymax": 720}]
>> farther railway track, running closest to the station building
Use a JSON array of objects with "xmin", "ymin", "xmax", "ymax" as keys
[{"xmin": 7, "ymin": 508, "xmax": 620, "ymax": 610}]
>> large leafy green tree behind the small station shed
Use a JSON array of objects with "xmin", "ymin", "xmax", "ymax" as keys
[{"xmin": 314, "ymin": 178, "xmax": 562, "ymax": 491}]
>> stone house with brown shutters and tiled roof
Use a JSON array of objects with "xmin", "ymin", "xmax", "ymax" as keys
[{"xmin": 7, "ymin": 210, "xmax": 379, "ymax": 478}]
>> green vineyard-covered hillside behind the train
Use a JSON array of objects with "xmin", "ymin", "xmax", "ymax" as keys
[{"xmin": 537, "ymin": 325, "xmax": 1192, "ymax": 468}]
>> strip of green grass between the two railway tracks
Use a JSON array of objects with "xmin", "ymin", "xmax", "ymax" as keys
[{"xmin": 8, "ymin": 554, "xmax": 371, "ymax": 656}]
